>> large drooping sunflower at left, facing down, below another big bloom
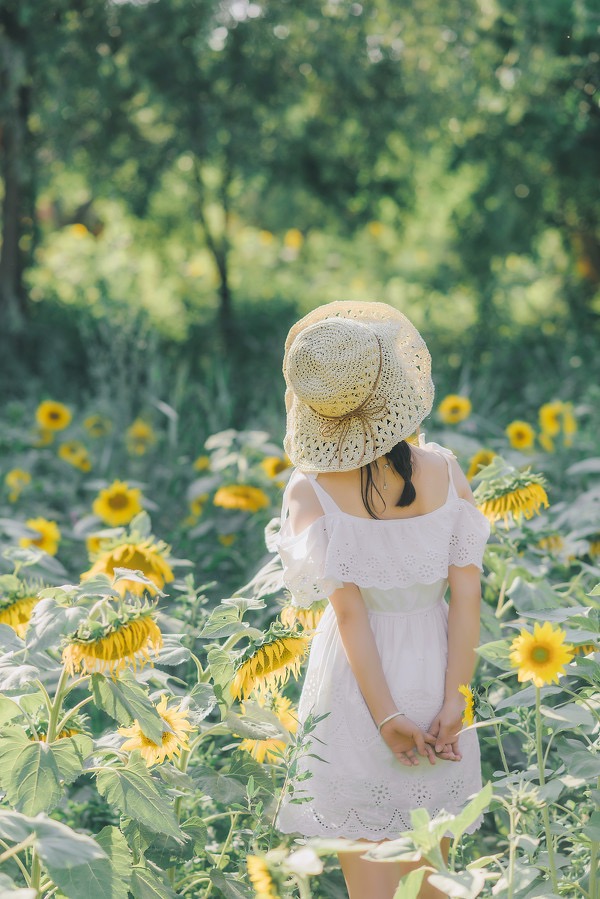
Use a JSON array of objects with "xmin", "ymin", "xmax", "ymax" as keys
[{"xmin": 62, "ymin": 606, "xmax": 162, "ymax": 676}]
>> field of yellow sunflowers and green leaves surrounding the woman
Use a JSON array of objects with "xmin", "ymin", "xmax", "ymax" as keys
[{"xmin": 0, "ymin": 393, "xmax": 600, "ymax": 899}]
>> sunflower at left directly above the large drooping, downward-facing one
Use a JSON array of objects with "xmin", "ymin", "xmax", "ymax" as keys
[{"xmin": 81, "ymin": 537, "xmax": 174, "ymax": 596}]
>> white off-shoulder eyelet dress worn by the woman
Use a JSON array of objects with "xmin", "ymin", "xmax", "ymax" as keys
[{"xmin": 274, "ymin": 443, "xmax": 489, "ymax": 840}]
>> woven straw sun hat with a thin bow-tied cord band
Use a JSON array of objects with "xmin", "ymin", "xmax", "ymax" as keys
[{"xmin": 283, "ymin": 301, "xmax": 434, "ymax": 472}]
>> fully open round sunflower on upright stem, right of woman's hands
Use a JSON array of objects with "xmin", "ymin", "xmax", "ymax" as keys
[{"xmin": 510, "ymin": 621, "xmax": 573, "ymax": 687}]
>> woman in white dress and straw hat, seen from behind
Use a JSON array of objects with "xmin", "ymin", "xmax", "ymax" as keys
[{"xmin": 276, "ymin": 302, "xmax": 489, "ymax": 899}]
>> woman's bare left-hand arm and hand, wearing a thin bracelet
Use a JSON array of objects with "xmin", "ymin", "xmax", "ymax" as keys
[{"xmin": 329, "ymin": 584, "xmax": 435, "ymax": 765}]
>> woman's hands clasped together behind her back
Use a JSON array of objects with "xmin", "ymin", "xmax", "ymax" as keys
[{"xmin": 381, "ymin": 697, "xmax": 464, "ymax": 767}]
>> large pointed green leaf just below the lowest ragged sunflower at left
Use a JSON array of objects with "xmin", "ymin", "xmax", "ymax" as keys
[{"xmin": 97, "ymin": 752, "xmax": 183, "ymax": 839}]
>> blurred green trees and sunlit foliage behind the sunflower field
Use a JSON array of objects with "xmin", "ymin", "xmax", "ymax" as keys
[{"xmin": 0, "ymin": 0, "xmax": 600, "ymax": 442}]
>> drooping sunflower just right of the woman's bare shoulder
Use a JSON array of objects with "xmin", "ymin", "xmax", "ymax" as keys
[{"xmin": 474, "ymin": 456, "xmax": 548, "ymax": 527}]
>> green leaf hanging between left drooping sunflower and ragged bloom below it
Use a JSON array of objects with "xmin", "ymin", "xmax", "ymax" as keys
[{"xmin": 91, "ymin": 671, "xmax": 164, "ymax": 746}]
